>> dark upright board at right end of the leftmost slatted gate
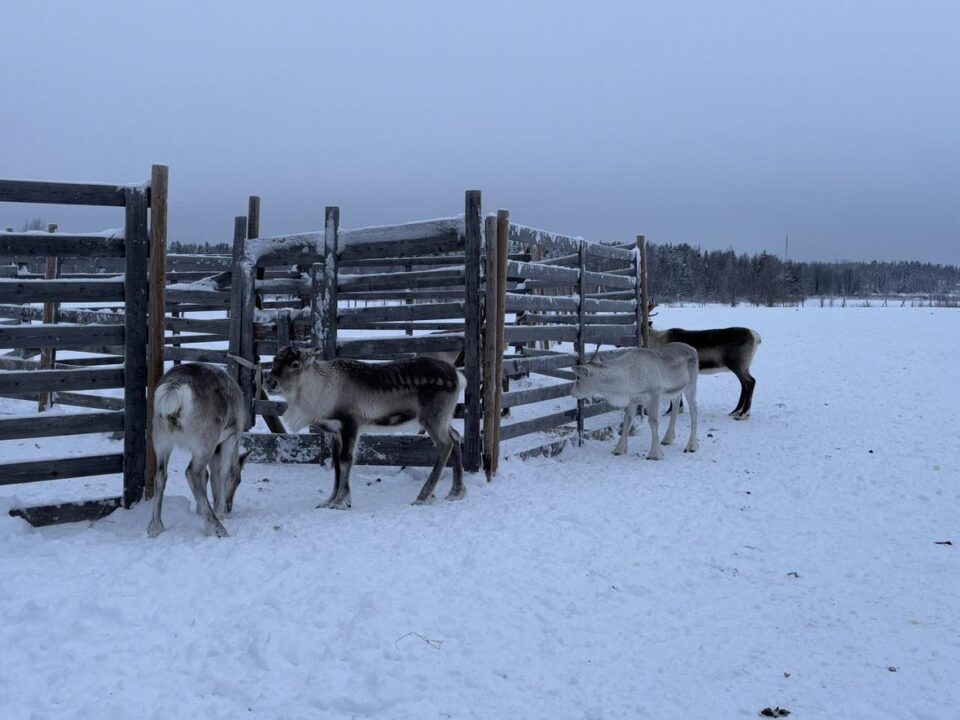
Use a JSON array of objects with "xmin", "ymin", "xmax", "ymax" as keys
[{"xmin": 123, "ymin": 189, "xmax": 149, "ymax": 507}]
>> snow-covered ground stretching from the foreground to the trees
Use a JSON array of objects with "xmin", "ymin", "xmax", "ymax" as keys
[{"xmin": 0, "ymin": 307, "xmax": 960, "ymax": 720}]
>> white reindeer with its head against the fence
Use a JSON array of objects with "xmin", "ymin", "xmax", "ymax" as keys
[{"xmin": 570, "ymin": 343, "xmax": 697, "ymax": 460}]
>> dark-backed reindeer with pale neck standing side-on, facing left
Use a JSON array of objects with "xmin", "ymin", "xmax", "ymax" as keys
[{"xmin": 264, "ymin": 347, "xmax": 466, "ymax": 510}]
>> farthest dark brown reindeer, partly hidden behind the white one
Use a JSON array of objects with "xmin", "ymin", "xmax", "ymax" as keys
[{"xmin": 650, "ymin": 327, "xmax": 760, "ymax": 420}]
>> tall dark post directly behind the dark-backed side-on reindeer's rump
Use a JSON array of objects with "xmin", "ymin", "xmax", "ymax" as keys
[{"xmin": 463, "ymin": 190, "xmax": 482, "ymax": 472}]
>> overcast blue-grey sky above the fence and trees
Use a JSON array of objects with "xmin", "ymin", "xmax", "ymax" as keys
[{"xmin": 0, "ymin": 0, "xmax": 960, "ymax": 263}]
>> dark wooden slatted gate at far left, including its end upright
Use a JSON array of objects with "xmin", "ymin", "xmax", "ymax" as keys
[{"xmin": 0, "ymin": 180, "xmax": 149, "ymax": 525}]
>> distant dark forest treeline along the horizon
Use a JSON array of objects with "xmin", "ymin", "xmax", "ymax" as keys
[{"xmin": 168, "ymin": 242, "xmax": 960, "ymax": 305}]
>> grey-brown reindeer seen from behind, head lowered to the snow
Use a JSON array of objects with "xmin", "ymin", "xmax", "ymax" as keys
[{"xmin": 147, "ymin": 363, "xmax": 247, "ymax": 537}]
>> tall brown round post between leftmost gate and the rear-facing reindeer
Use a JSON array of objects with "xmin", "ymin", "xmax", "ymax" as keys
[{"xmin": 143, "ymin": 165, "xmax": 169, "ymax": 499}]
